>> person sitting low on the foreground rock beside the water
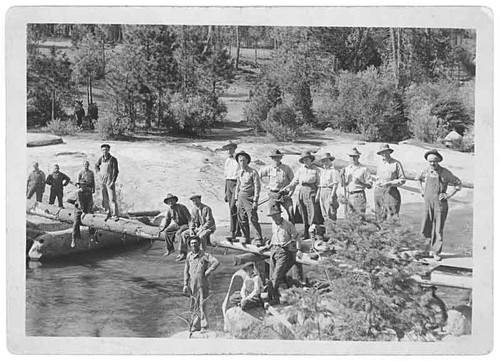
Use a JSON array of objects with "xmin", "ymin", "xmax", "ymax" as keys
[{"xmin": 229, "ymin": 262, "xmax": 263, "ymax": 311}]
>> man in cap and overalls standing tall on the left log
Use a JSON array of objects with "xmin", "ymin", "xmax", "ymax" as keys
[{"xmin": 95, "ymin": 144, "xmax": 119, "ymax": 220}]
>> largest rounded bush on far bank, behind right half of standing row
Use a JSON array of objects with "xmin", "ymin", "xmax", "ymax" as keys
[{"xmin": 321, "ymin": 68, "xmax": 407, "ymax": 141}]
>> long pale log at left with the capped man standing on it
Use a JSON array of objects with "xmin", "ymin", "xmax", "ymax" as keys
[{"xmin": 26, "ymin": 200, "xmax": 165, "ymax": 239}]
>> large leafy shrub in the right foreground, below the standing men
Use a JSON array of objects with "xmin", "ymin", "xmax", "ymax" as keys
[{"xmin": 274, "ymin": 219, "xmax": 442, "ymax": 341}]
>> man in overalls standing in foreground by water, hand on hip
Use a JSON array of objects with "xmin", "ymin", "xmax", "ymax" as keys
[{"xmin": 182, "ymin": 236, "xmax": 219, "ymax": 332}]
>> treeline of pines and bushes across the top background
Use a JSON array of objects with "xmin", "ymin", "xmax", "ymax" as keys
[{"xmin": 28, "ymin": 24, "xmax": 475, "ymax": 148}]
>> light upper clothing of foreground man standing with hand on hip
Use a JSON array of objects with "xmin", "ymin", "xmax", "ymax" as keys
[{"xmin": 184, "ymin": 249, "xmax": 220, "ymax": 290}]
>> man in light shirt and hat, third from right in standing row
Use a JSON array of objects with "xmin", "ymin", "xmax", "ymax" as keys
[{"xmin": 340, "ymin": 147, "xmax": 372, "ymax": 218}]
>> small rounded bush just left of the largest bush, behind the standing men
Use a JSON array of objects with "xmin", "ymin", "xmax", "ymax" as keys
[{"xmin": 263, "ymin": 105, "xmax": 303, "ymax": 141}]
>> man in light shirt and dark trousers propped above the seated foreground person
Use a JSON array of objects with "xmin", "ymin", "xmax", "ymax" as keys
[{"xmin": 259, "ymin": 207, "xmax": 302, "ymax": 304}]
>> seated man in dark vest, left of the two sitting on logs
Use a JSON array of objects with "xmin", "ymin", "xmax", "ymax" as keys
[{"xmin": 158, "ymin": 193, "xmax": 191, "ymax": 261}]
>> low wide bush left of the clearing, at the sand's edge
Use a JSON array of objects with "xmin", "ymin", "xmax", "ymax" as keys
[{"xmin": 170, "ymin": 93, "xmax": 227, "ymax": 134}]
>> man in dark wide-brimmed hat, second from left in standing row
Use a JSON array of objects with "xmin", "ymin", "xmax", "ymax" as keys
[{"xmin": 235, "ymin": 151, "xmax": 263, "ymax": 243}]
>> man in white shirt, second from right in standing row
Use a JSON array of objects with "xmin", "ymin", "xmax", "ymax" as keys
[{"xmin": 373, "ymin": 144, "xmax": 406, "ymax": 222}]
